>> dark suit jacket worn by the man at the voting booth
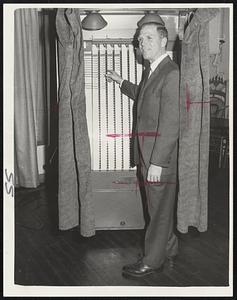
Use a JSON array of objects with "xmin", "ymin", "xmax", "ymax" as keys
[{"xmin": 121, "ymin": 56, "xmax": 179, "ymax": 174}]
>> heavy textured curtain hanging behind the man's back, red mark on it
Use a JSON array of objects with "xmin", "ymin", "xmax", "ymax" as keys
[{"xmin": 177, "ymin": 8, "xmax": 218, "ymax": 233}]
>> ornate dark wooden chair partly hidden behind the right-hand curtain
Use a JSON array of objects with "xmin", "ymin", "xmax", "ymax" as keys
[{"xmin": 209, "ymin": 76, "xmax": 229, "ymax": 168}]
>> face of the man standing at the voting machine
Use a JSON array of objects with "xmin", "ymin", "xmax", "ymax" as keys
[{"xmin": 138, "ymin": 24, "xmax": 165, "ymax": 63}]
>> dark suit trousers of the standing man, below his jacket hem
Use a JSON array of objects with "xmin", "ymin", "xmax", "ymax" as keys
[{"xmin": 140, "ymin": 160, "xmax": 178, "ymax": 268}]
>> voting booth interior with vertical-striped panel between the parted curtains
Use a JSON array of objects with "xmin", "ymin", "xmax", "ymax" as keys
[{"xmin": 83, "ymin": 15, "xmax": 178, "ymax": 229}]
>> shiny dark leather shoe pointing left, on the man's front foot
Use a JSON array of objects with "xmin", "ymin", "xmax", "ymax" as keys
[{"xmin": 123, "ymin": 260, "xmax": 163, "ymax": 277}]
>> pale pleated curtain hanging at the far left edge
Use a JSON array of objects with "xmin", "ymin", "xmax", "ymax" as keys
[{"xmin": 14, "ymin": 9, "xmax": 39, "ymax": 187}]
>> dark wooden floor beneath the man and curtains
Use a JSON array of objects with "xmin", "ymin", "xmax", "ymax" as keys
[{"xmin": 15, "ymin": 162, "xmax": 229, "ymax": 287}]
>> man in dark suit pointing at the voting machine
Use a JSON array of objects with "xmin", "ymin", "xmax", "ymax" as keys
[{"xmin": 106, "ymin": 15, "xmax": 179, "ymax": 277}]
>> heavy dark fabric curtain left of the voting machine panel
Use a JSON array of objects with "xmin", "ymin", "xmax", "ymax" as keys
[{"xmin": 56, "ymin": 8, "xmax": 95, "ymax": 236}]
